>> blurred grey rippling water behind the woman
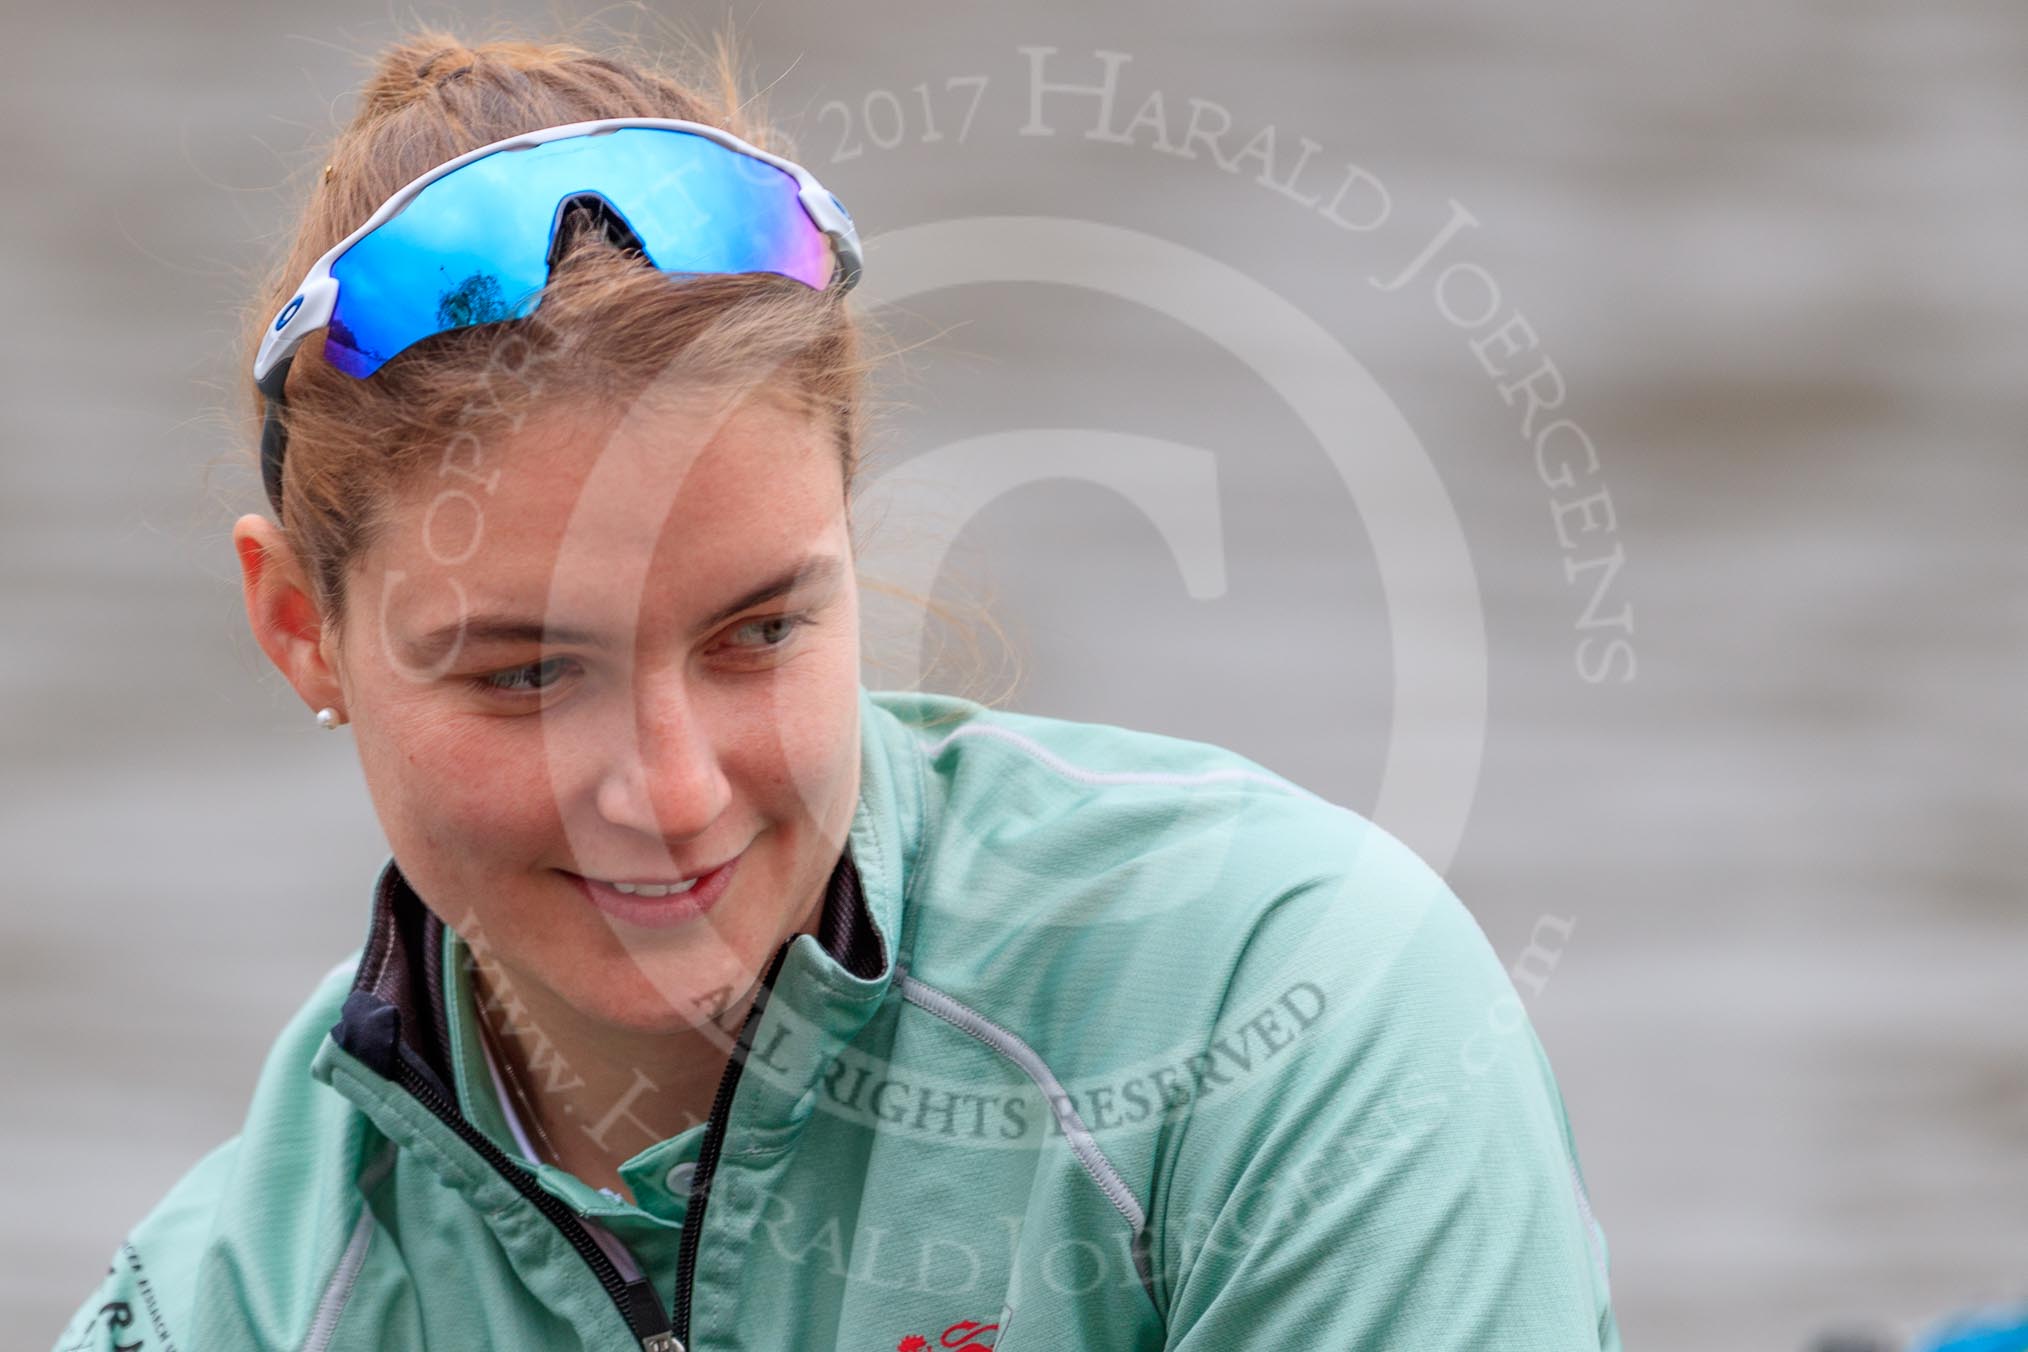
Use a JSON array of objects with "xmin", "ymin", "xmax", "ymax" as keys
[{"xmin": 0, "ymin": 0, "xmax": 2028, "ymax": 1352}]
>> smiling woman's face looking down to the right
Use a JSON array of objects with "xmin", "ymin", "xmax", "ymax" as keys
[{"xmin": 322, "ymin": 385, "xmax": 860, "ymax": 1032}]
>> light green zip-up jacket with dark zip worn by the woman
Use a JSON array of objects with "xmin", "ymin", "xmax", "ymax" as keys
[{"xmin": 57, "ymin": 691, "xmax": 1618, "ymax": 1352}]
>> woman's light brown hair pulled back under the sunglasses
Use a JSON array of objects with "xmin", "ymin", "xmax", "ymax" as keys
[{"xmin": 241, "ymin": 28, "xmax": 1018, "ymax": 713}]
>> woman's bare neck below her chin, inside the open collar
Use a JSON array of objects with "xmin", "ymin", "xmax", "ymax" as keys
[{"xmin": 473, "ymin": 894, "xmax": 823, "ymax": 1202}]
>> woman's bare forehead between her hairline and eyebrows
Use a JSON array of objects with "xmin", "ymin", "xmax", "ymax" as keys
[{"xmin": 361, "ymin": 395, "xmax": 846, "ymax": 632}]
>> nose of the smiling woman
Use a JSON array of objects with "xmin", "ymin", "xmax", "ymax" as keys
[{"xmin": 598, "ymin": 673, "xmax": 732, "ymax": 841}]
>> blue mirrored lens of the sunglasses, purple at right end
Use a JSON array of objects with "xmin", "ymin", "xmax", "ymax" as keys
[{"xmin": 324, "ymin": 128, "xmax": 831, "ymax": 379}]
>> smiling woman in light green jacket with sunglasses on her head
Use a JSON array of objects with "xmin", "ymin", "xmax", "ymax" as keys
[{"xmin": 59, "ymin": 23, "xmax": 1618, "ymax": 1352}]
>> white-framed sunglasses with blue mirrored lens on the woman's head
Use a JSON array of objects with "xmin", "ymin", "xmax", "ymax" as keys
[{"xmin": 254, "ymin": 118, "xmax": 860, "ymax": 517}]
